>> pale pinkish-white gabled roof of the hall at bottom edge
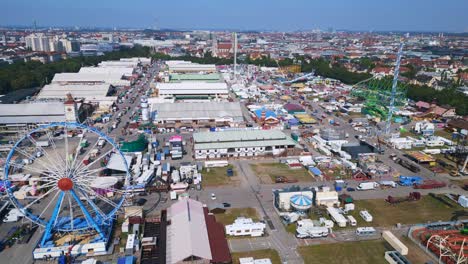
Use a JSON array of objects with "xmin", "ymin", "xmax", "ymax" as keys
[{"xmin": 166, "ymin": 199, "xmax": 212, "ymax": 264}]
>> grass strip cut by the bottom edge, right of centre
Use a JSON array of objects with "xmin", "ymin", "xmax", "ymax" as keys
[{"xmin": 298, "ymin": 240, "xmax": 390, "ymax": 264}]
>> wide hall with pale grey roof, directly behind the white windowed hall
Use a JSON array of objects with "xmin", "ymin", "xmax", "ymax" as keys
[{"xmin": 151, "ymin": 102, "xmax": 244, "ymax": 128}]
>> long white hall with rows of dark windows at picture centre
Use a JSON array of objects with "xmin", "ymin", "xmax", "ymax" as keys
[{"xmin": 193, "ymin": 130, "xmax": 296, "ymax": 159}]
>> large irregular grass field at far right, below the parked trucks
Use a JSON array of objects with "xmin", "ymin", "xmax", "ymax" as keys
[{"xmin": 352, "ymin": 196, "xmax": 463, "ymax": 227}]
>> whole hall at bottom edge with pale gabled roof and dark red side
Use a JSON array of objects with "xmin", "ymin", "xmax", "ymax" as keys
[{"xmin": 165, "ymin": 199, "xmax": 232, "ymax": 264}]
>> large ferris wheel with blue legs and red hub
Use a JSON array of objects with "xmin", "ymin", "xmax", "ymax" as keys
[{"xmin": 4, "ymin": 122, "xmax": 130, "ymax": 246}]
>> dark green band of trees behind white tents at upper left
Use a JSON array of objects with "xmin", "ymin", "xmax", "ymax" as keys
[{"xmin": 0, "ymin": 46, "xmax": 150, "ymax": 94}]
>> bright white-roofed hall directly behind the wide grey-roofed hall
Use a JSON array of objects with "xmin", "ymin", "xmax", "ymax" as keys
[{"xmin": 156, "ymin": 81, "xmax": 229, "ymax": 100}]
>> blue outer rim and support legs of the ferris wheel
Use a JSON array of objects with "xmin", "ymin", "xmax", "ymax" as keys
[{"xmin": 4, "ymin": 122, "xmax": 130, "ymax": 235}]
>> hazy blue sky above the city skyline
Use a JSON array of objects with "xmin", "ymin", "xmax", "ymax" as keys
[{"xmin": 0, "ymin": 0, "xmax": 468, "ymax": 32}]
